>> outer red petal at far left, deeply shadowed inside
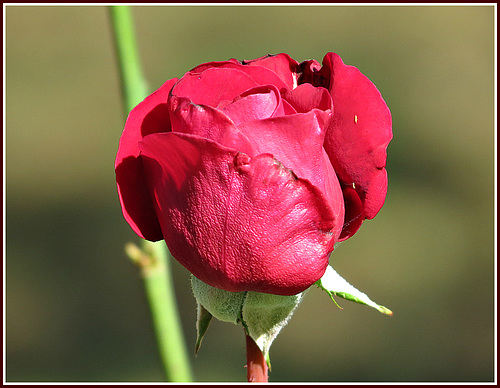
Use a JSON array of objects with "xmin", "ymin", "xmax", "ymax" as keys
[{"xmin": 115, "ymin": 78, "xmax": 177, "ymax": 241}]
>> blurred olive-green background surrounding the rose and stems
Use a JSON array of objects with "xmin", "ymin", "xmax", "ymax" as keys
[{"xmin": 4, "ymin": 6, "xmax": 496, "ymax": 382}]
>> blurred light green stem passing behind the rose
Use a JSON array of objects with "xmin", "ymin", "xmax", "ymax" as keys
[{"xmin": 109, "ymin": 6, "xmax": 192, "ymax": 382}]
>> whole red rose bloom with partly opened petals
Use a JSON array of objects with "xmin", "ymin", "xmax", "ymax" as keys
[{"xmin": 115, "ymin": 53, "xmax": 392, "ymax": 295}]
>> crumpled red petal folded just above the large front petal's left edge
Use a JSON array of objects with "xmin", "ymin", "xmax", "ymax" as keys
[{"xmin": 169, "ymin": 96, "xmax": 254, "ymax": 155}]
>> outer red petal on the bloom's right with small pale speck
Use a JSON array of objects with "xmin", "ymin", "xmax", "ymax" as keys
[{"xmin": 321, "ymin": 53, "xmax": 392, "ymax": 219}]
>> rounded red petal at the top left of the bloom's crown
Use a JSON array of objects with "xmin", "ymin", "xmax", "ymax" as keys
[{"xmin": 172, "ymin": 66, "xmax": 259, "ymax": 108}]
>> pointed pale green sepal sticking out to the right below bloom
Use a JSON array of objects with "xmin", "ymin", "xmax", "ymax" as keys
[{"xmin": 316, "ymin": 266, "xmax": 392, "ymax": 315}]
